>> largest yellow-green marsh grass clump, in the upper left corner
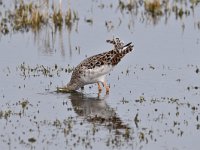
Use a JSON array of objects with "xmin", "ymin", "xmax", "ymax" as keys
[{"xmin": 0, "ymin": 0, "xmax": 79, "ymax": 35}]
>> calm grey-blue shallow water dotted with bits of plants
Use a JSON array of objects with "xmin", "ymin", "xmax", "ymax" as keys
[{"xmin": 0, "ymin": 1, "xmax": 200, "ymax": 150}]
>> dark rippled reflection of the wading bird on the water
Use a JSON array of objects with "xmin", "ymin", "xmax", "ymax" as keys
[{"xmin": 69, "ymin": 92, "xmax": 128, "ymax": 129}]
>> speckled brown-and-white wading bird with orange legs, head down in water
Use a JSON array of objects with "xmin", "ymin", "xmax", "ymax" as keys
[{"xmin": 63, "ymin": 38, "xmax": 133, "ymax": 92}]
